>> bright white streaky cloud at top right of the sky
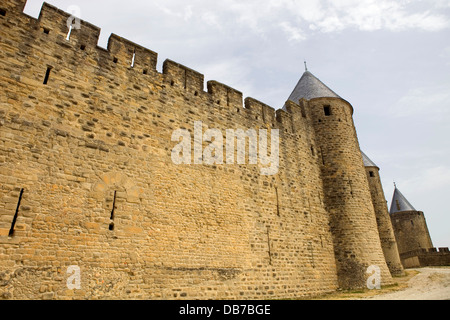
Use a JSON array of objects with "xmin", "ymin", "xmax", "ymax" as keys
[{"xmin": 223, "ymin": 0, "xmax": 450, "ymax": 41}]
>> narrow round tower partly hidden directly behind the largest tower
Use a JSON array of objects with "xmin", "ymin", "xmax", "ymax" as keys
[{"xmin": 361, "ymin": 152, "xmax": 404, "ymax": 275}]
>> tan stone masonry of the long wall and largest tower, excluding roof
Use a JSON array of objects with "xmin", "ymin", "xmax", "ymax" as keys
[{"xmin": 0, "ymin": 0, "xmax": 390, "ymax": 299}]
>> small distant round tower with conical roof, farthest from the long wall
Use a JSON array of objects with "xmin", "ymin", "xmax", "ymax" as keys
[{"xmin": 390, "ymin": 186, "xmax": 433, "ymax": 256}]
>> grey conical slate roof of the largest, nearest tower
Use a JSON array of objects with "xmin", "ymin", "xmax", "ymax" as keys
[{"xmin": 289, "ymin": 71, "xmax": 340, "ymax": 103}]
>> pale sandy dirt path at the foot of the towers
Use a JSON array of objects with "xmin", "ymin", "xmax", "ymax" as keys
[{"xmin": 363, "ymin": 267, "xmax": 450, "ymax": 300}]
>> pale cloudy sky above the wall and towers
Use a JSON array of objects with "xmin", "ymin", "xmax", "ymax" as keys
[{"xmin": 25, "ymin": 0, "xmax": 450, "ymax": 247}]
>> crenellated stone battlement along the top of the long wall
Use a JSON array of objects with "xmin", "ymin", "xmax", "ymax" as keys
[{"xmin": 5, "ymin": 0, "xmax": 291, "ymax": 123}]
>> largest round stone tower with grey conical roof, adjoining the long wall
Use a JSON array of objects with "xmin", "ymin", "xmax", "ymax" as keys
[{"xmin": 289, "ymin": 71, "xmax": 392, "ymax": 289}]
